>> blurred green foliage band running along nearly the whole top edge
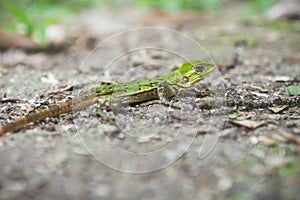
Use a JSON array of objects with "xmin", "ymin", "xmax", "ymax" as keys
[{"xmin": 0, "ymin": 0, "xmax": 276, "ymax": 42}]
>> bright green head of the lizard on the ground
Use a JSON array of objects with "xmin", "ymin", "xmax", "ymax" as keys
[{"xmin": 178, "ymin": 60, "xmax": 215, "ymax": 87}]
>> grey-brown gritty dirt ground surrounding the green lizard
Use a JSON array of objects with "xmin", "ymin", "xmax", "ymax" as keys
[{"xmin": 0, "ymin": 1, "xmax": 300, "ymax": 200}]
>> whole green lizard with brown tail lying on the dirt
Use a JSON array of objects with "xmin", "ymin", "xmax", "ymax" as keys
[{"xmin": 0, "ymin": 60, "xmax": 215, "ymax": 137}]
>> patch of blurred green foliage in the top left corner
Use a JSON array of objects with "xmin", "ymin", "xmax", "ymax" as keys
[{"xmin": 0, "ymin": 0, "xmax": 96, "ymax": 42}]
